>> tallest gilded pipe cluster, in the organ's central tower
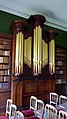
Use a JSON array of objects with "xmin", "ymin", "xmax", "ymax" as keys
[{"xmin": 33, "ymin": 26, "xmax": 42, "ymax": 75}]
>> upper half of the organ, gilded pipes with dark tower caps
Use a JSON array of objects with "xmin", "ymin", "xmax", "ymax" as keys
[{"xmin": 11, "ymin": 15, "xmax": 55, "ymax": 75}]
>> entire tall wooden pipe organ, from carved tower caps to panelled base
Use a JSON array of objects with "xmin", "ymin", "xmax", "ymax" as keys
[{"xmin": 10, "ymin": 15, "xmax": 57, "ymax": 107}]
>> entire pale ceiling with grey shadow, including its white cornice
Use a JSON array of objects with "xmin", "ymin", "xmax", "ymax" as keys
[{"xmin": 0, "ymin": 0, "xmax": 67, "ymax": 31}]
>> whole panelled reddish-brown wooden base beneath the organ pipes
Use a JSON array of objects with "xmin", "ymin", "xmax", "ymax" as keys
[{"xmin": 11, "ymin": 79, "xmax": 55, "ymax": 107}]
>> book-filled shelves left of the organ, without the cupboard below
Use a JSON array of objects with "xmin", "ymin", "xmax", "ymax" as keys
[{"xmin": 0, "ymin": 38, "xmax": 11, "ymax": 89}]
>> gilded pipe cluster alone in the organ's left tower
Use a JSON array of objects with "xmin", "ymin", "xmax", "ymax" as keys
[{"xmin": 15, "ymin": 32, "xmax": 23, "ymax": 74}]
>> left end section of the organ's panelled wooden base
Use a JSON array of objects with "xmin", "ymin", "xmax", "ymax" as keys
[{"xmin": 11, "ymin": 80, "xmax": 23, "ymax": 106}]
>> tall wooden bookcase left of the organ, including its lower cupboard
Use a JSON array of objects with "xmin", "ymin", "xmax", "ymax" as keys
[{"xmin": 0, "ymin": 33, "xmax": 12, "ymax": 115}]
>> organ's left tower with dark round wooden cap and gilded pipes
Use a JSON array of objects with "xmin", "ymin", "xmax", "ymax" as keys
[{"xmin": 10, "ymin": 20, "xmax": 28, "ymax": 75}]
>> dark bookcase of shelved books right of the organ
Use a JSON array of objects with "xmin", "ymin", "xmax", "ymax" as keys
[{"xmin": 55, "ymin": 46, "xmax": 67, "ymax": 84}]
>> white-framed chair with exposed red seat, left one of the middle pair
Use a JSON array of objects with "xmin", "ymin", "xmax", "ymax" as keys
[{"xmin": 21, "ymin": 96, "xmax": 37, "ymax": 117}]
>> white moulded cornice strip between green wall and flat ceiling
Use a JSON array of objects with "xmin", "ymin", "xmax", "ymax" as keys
[{"xmin": 0, "ymin": 5, "xmax": 67, "ymax": 31}]
